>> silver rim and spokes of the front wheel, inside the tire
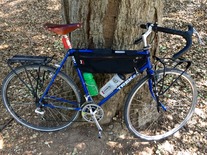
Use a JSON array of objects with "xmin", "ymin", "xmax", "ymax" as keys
[{"xmin": 126, "ymin": 71, "xmax": 197, "ymax": 140}]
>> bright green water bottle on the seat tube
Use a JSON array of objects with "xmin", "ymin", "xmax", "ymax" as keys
[{"xmin": 83, "ymin": 73, "xmax": 98, "ymax": 96}]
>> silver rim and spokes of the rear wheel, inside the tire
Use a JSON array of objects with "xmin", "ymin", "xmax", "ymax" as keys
[{"xmin": 3, "ymin": 66, "xmax": 80, "ymax": 131}]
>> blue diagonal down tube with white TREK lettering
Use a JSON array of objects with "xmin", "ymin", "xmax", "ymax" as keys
[{"xmin": 98, "ymin": 73, "xmax": 139, "ymax": 106}]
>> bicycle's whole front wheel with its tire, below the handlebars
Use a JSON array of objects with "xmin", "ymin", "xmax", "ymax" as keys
[{"xmin": 124, "ymin": 69, "xmax": 197, "ymax": 141}]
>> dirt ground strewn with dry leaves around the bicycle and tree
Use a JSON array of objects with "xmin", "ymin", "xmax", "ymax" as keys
[{"xmin": 0, "ymin": 0, "xmax": 207, "ymax": 155}]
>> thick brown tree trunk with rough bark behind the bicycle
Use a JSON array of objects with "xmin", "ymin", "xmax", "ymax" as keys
[{"xmin": 62, "ymin": 0, "xmax": 163, "ymax": 123}]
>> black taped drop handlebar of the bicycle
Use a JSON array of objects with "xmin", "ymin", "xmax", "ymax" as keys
[{"xmin": 140, "ymin": 23, "xmax": 193, "ymax": 60}]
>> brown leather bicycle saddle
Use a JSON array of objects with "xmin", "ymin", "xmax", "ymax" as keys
[{"xmin": 44, "ymin": 23, "xmax": 81, "ymax": 35}]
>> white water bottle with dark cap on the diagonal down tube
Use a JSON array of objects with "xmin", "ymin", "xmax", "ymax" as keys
[{"xmin": 100, "ymin": 74, "xmax": 125, "ymax": 97}]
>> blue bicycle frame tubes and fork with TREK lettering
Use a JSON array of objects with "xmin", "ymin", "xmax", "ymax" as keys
[{"xmin": 39, "ymin": 49, "xmax": 155, "ymax": 111}]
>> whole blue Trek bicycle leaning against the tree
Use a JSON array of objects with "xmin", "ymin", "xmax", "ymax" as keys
[{"xmin": 2, "ymin": 23, "xmax": 200, "ymax": 141}]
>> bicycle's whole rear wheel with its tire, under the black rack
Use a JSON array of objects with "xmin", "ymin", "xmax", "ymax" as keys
[{"xmin": 2, "ymin": 65, "xmax": 81, "ymax": 132}]
